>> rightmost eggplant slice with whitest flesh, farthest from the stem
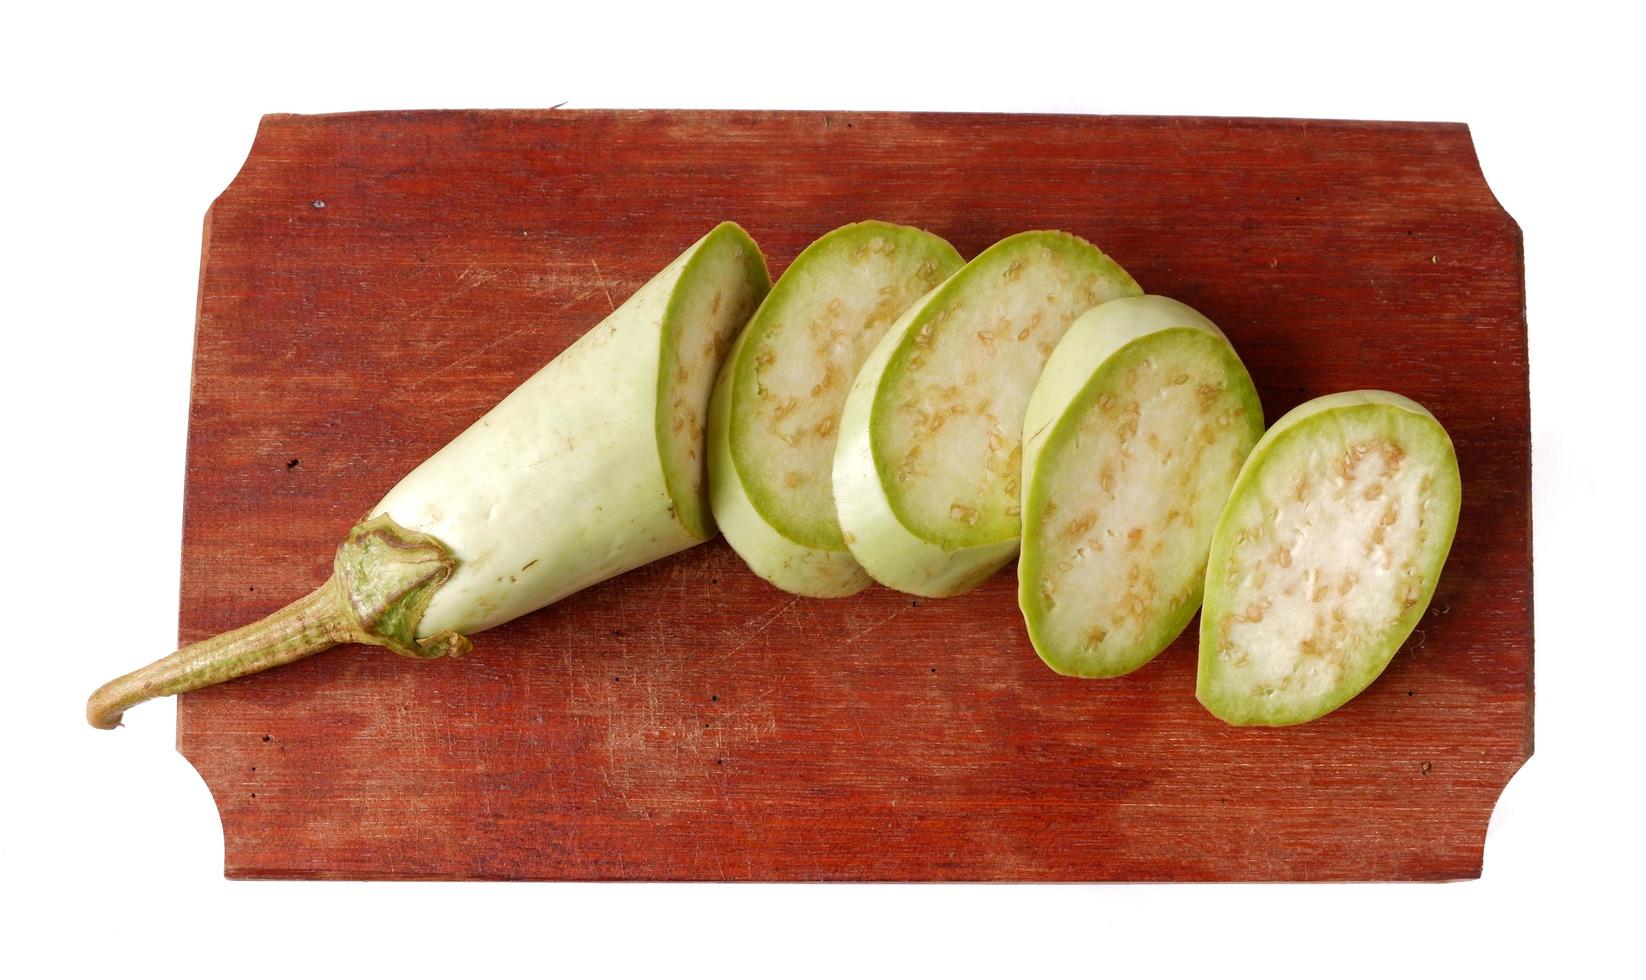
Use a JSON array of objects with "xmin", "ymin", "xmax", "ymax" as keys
[{"xmin": 1195, "ymin": 390, "xmax": 1462, "ymax": 725}]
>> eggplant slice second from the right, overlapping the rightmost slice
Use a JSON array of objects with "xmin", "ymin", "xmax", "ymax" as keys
[{"xmin": 1017, "ymin": 296, "xmax": 1262, "ymax": 677}]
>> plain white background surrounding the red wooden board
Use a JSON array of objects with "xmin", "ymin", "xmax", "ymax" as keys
[{"xmin": 0, "ymin": 0, "xmax": 1646, "ymax": 977}]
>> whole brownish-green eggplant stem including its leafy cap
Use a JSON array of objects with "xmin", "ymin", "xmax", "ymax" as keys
[{"xmin": 86, "ymin": 514, "xmax": 469, "ymax": 730}]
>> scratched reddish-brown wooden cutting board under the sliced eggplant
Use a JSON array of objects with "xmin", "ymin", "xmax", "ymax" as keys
[{"xmin": 178, "ymin": 112, "xmax": 1532, "ymax": 880}]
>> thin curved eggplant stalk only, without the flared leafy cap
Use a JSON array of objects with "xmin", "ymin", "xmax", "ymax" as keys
[{"xmin": 86, "ymin": 576, "xmax": 353, "ymax": 730}]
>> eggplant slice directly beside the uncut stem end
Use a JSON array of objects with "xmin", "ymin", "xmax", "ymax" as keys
[{"xmin": 708, "ymin": 221, "xmax": 965, "ymax": 598}]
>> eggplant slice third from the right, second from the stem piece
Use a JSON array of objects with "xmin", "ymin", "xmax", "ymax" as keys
[{"xmin": 835, "ymin": 231, "xmax": 1142, "ymax": 596}]
